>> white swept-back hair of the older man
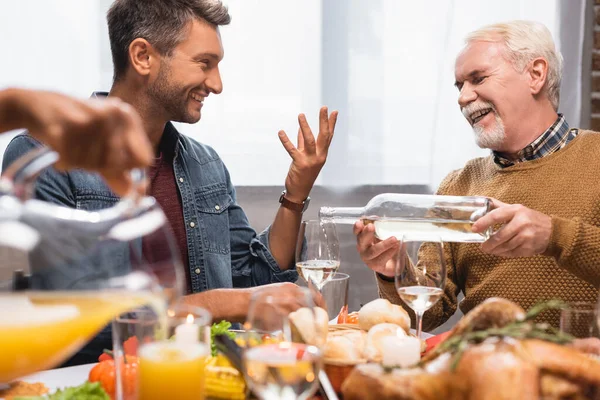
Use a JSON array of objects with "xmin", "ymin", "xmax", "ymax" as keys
[{"xmin": 465, "ymin": 21, "xmax": 563, "ymax": 110}]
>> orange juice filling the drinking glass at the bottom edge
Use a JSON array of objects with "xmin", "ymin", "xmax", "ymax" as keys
[{"xmin": 138, "ymin": 341, "xmax": 210, "ymax": 400}]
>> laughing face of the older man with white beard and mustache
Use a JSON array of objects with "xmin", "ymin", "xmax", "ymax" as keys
[{"xmin": 455, "ymin": 41, "xmax": 532, "ymax": 152}]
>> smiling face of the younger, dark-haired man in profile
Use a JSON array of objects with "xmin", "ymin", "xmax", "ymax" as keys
[{"xmin": 148, "ymin": 19, "xmax": 223, "ymax": 124}]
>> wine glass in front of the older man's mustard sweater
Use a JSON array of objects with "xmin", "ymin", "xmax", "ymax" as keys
[{"xmin": 395, "ymin": 236, "xmax": 446, "ymax": 339}]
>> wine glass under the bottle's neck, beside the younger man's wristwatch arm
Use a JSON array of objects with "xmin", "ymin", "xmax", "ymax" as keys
[{"xmin": 296, "ymin": 220, "xmax": 340, "ymax": 291}]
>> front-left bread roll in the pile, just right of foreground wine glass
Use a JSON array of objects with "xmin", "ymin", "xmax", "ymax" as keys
[{"xmin": 323, "ymin": 330, "xmax": 367, "ymax": 363}]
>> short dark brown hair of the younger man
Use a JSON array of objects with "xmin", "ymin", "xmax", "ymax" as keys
[{"xmin": 107, "ymin": 0, "xmax": 231, "ymax": 81}]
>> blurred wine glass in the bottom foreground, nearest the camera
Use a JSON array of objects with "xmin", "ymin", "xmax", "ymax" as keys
[{"xmin": 243, "ymin": 287, "xmax": 328, "ymax": 400}]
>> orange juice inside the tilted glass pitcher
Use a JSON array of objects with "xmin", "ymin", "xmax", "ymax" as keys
[{"xmin": 0, "ymin": 291, "xmax": 161, "ymax": 383}]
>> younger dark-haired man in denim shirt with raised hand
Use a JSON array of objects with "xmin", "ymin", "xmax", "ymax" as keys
[{"xmin": 3, "ymin": 0, "xmax": 337, "ymax": 362}]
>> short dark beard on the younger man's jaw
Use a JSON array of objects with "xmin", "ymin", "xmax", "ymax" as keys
[{"xmin": 148, "ymin": 61, "xmax": 200, "ymax": 124}]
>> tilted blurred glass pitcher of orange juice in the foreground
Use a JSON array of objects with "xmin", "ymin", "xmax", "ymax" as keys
[{"xmin": 0, "ymin": 149, "xmax": 185, "ymax": 382}]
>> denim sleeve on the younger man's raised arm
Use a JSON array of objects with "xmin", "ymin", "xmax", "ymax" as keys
[{"xmin": 224, "ymin": 167, "xmax": 298, "ymax": 287}]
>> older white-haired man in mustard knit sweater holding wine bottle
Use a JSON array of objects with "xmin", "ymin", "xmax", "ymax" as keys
[{"xmin": 354, "ymin": 21, "xmax": 600, "ymax": 329}]
